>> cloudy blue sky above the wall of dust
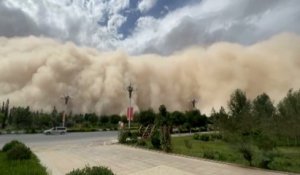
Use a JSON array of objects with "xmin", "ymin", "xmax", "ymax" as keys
[{"xmin": 0, "ymin": 0, "xmax": 300, "ymax": 55}]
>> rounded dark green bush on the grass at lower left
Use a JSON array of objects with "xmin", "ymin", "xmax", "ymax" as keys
[{"xmin": 6, "ymin": 144, "xmax": 32, "ymax": 160}]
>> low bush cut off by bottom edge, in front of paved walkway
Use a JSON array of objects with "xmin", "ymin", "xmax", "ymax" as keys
[{"xmin": 66, "ymin": 166, "xmax": 114, "ymax": 175}]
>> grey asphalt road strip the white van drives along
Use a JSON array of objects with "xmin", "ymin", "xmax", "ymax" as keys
[{"xmin": 0, "ymin": 131, "xmax": 118, "ymax": 148}]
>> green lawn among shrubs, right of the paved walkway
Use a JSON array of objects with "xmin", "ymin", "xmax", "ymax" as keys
[{"xmin": 172, "ymin": 136, "xmax": 300, "ymax": 173}]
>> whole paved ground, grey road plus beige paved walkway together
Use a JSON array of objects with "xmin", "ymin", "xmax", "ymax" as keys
[{"xmin": 0, "ymin": 132, "xmax": 290, "ymax": 175}]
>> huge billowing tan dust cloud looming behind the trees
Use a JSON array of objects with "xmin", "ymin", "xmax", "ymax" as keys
[{"xmin": 0, "ymin": 34, "xmax": 300, "ymax": 114}]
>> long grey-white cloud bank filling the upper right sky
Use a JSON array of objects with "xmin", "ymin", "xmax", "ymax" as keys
[{"xmin": 122, "ymin": 0, "xmax": 300, "ymax": 54}]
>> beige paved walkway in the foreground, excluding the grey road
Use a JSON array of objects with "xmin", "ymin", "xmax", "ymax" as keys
[{"xmin": 32, "ymin": 140, "xmax": 288, "ymax": 175}]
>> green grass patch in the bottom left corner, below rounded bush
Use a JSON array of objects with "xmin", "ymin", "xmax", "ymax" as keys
[{"xmin": 0, "ymin": 152, "xmax": 47, "ymax": 175}]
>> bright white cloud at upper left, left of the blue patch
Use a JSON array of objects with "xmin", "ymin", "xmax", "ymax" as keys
[{"xmin": 0, "ymin": 0, "xmax": 129, "ymax": 50}]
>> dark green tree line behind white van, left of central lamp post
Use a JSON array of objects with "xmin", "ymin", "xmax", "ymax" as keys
[{"xmin": 0, "ymin": 104, "xmax": 127, "ymax": 132}]
